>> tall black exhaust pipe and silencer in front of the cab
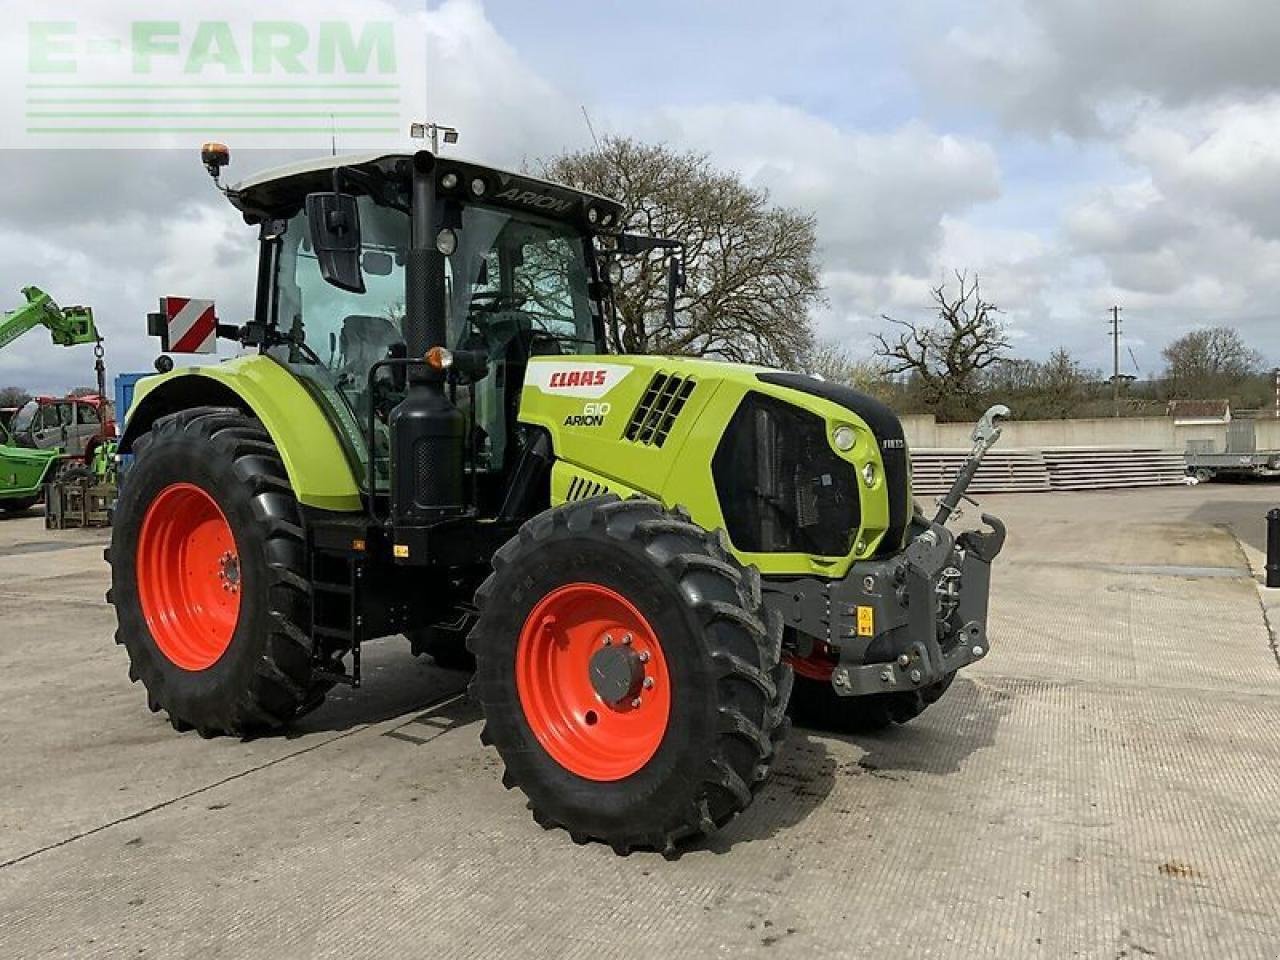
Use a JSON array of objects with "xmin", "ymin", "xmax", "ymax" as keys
[{"xmin": 388, "ymin": 150, "xmax": 466, "ymax": 529}]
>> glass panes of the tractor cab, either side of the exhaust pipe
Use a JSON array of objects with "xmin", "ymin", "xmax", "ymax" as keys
[{"xmin": 270, "ymin": 197, "xmax": 600, "ymax": 488}]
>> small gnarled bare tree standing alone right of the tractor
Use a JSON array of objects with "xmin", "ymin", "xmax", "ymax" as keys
[{"xmin": 876, "ymin": 271, "xmax": 1009, "ymax": 417}]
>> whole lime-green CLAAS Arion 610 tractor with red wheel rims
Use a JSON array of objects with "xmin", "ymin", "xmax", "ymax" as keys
[{"xmin": 109, "ymin": 145, "xmax": 1007, "ymax": 854}]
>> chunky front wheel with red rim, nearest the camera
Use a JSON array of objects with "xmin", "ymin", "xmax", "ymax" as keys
[{"xmin": 468, "ymin": 497, "xmax": 791, "ymax": 855}]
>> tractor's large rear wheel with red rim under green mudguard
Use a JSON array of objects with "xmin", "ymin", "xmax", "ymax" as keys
[{"xmin": 108, "ymin": 407, "xmax": 326, "ymax": 736}]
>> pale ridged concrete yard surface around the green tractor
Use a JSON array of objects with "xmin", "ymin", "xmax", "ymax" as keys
[{"xmin": 0, "ymin": 484, "xmax": 1280, "ymax": 960}]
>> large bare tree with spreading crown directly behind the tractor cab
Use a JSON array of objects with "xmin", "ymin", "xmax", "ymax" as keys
[{"xmin": 538, "ymin": 137, "xmax": 822, "ymax": 366}]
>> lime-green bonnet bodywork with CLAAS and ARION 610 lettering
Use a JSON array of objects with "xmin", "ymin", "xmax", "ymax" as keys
[{"xmin": 520, "ymin": 356, "xmax": 890, "ymax": 577}]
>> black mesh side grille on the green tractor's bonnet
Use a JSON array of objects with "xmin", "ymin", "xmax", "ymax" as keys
[{"xmin": 712, "ymin": 393, "xmax": 861, "ymax": 557}]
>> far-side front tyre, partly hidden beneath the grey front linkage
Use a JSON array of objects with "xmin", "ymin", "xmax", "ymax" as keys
[{"xmin": 791, "ymin": 659, "xmax": 955, "ymax": 733}]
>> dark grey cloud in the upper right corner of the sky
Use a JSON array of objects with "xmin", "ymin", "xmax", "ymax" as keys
[{"xmin": 916, "ymin": 0, "xmax": 1280, "ymax": 136}]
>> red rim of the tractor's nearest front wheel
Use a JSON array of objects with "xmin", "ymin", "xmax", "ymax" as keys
[{"xmin": 516, "ymin": 584, "xmax": 671, "ymax": 781}]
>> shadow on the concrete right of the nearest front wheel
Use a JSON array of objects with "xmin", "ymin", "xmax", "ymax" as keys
[{"xmin": 687, "ymin": 676, "xmax": 1012, "ymax": 854}]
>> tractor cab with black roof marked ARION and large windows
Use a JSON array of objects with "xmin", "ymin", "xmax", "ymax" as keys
[{"xmin": 228, "ymin": 152, "xmax": 652, "ymax": 513}]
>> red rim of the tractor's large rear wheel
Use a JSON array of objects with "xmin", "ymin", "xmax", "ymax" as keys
[{"xmin": 137, "ymin": 484, "xmax": 241, "ymax": 671}]
